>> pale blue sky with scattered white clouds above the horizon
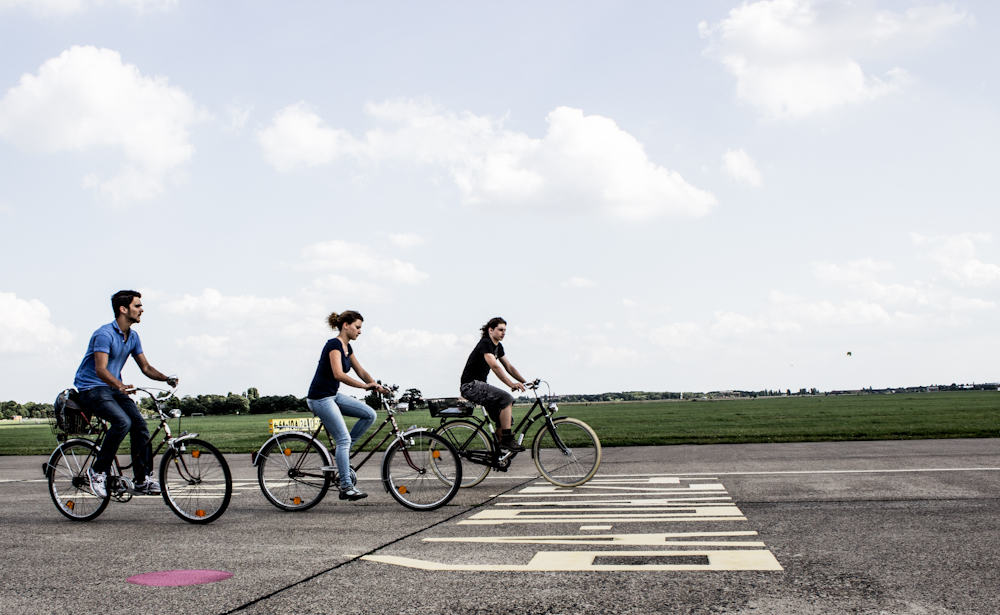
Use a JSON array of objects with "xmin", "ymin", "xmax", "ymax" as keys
[{"xmin": 0, "ymin": 0, "xmax": 1000, "ymax": 401}]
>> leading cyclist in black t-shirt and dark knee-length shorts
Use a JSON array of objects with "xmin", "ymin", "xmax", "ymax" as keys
[{"xmin": 459, "ymin": 316, "xmax": 527, "ymax": 451}]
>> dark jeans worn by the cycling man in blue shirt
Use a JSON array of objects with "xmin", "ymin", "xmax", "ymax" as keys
[{"xmin": 80, "ymin": 387, "xmax": 153, "ymax": 482}]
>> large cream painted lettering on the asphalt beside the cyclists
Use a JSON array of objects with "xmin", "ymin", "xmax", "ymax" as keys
[{"xmin": 362, "ymin": 475, "xmax": 782, "ymax": 572}]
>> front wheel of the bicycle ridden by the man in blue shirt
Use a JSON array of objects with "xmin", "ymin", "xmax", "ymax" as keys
[{"xmin": 160, "ymin": 438, "xmax": 233, "ymax": 524}]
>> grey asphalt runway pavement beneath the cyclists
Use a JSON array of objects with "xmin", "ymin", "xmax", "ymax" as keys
[{"xmin": 0, "ymin": 439, "xmax": 1000, "ymax": 615}]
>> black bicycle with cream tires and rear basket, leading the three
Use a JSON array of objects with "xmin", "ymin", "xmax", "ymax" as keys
[{"xmin": 427, "ymin": 380, "xmax": 601, "ymax": 488}]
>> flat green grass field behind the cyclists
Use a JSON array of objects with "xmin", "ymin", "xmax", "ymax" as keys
[{"xmin": 0, "ymin": 391, "xmax": 1000, "ymax": 455}]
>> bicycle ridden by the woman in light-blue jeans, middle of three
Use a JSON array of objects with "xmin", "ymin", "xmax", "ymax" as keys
[{"xmin": 251, "ymin": 386, "xmax": 462, "ymax": 511}]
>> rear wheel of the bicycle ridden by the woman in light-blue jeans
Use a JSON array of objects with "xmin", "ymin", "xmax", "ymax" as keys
[{"xmin": 257, "ymin": 433, "xmax": 333, "ymax": 512}]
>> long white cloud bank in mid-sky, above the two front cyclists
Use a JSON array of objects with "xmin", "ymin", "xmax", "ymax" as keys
[{"xmin": 258, "ymin": 101, "xmax": 716, "ymax": 219}]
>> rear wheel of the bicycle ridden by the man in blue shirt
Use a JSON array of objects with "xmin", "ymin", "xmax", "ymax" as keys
[{"xmin": 46, "ymin": 439, "xmax": 111, "ymax": 521}]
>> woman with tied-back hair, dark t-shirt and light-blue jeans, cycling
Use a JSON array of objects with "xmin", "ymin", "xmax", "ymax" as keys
[{"xmin": 306, "ymin": 310, "xmax": 388, "ymax": 500}]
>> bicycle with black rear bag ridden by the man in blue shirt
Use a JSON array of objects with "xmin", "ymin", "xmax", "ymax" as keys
[{"xmin": 42, "ymin": 388, "xmax": 233, "ymax": 524}]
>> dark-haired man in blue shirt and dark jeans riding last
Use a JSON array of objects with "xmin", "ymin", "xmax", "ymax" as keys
[{"xmin": 73, "ymin": 290, "xmax": 177, "ymax": 498}]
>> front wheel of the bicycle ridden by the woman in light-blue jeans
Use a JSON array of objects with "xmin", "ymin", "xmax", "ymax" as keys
[{"xmin": 382, "ymin": 430, "xmax": 462, "ymax": 510}]
